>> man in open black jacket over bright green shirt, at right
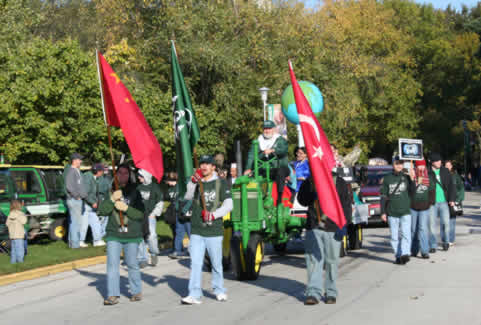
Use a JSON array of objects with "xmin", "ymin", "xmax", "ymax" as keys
[{"xmin": 429, "ymin": 152, "xmax": 456, "ymax": 253}]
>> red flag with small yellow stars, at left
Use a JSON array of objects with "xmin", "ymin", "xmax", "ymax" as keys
[{"xmin": 97, "ymin": 52, "xmax": 164, "ymax": 182}]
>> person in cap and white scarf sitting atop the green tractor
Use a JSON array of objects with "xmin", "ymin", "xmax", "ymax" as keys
[{"xmin": 244, "ymin": 120, "xmax": 290, "ymax": 203}]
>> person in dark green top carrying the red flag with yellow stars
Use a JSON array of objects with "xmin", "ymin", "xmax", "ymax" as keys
[{"xmin": 98, "ymin": 165, "xmax": 144, "ymax": 305}]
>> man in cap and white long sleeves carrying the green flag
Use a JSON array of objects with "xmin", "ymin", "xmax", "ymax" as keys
[{"xmin": 181, "ymin": 155, "xmax": 233, "ymax": 305}]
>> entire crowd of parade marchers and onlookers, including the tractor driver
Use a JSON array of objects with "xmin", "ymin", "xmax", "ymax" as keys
[{"xmin": 1, "ymin": 121, "xmax": 464, "ymax": 305}]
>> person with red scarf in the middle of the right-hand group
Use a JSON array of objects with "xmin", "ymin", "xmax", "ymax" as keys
[{"xmin": 411, "ymin": 159, "xmax": 436, "ymax": 259}]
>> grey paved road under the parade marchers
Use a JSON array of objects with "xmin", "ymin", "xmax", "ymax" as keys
[{"xmin": 0, "ymin": 193, "xmax": 481, "ymax": 325}]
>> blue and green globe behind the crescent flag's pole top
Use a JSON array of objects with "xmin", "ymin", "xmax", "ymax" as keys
[{"xmin": 281, "ymin": 81, "xmax": 324, "ymax": 124}]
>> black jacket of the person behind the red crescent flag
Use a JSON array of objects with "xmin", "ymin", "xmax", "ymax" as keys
[{"xmin": 297, "ymin": 176, "xmax": 352, "ymax": 232}]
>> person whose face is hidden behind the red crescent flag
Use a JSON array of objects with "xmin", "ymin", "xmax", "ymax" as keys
[{"xmin": 297, "ymin": 170, "xmax": 352, "ymax": 305}]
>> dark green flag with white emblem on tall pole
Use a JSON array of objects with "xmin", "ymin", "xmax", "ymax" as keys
[{"xmin": 172, "ymin": 41, "xmax": 200, "ymax": 195}]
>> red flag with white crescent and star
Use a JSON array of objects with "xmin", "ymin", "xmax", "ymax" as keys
[{"xmin": 289, "ymin": 61, "xmax": 346, "ymax": 228}]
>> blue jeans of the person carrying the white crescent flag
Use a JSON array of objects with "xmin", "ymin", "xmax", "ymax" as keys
[{"xmin": 304, "ymin": 229, "xmax": 342, "ymax": 300}]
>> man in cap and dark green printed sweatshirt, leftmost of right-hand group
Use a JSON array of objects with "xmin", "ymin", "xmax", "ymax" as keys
[{"xmin": 381, "ymin": 156, "xmax": 414, "ymax": 264}]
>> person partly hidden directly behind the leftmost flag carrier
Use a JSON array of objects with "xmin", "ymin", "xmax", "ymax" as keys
[{"xmin": 137, "ymin": 169, "xmax": 164, "ymax": 268}]
